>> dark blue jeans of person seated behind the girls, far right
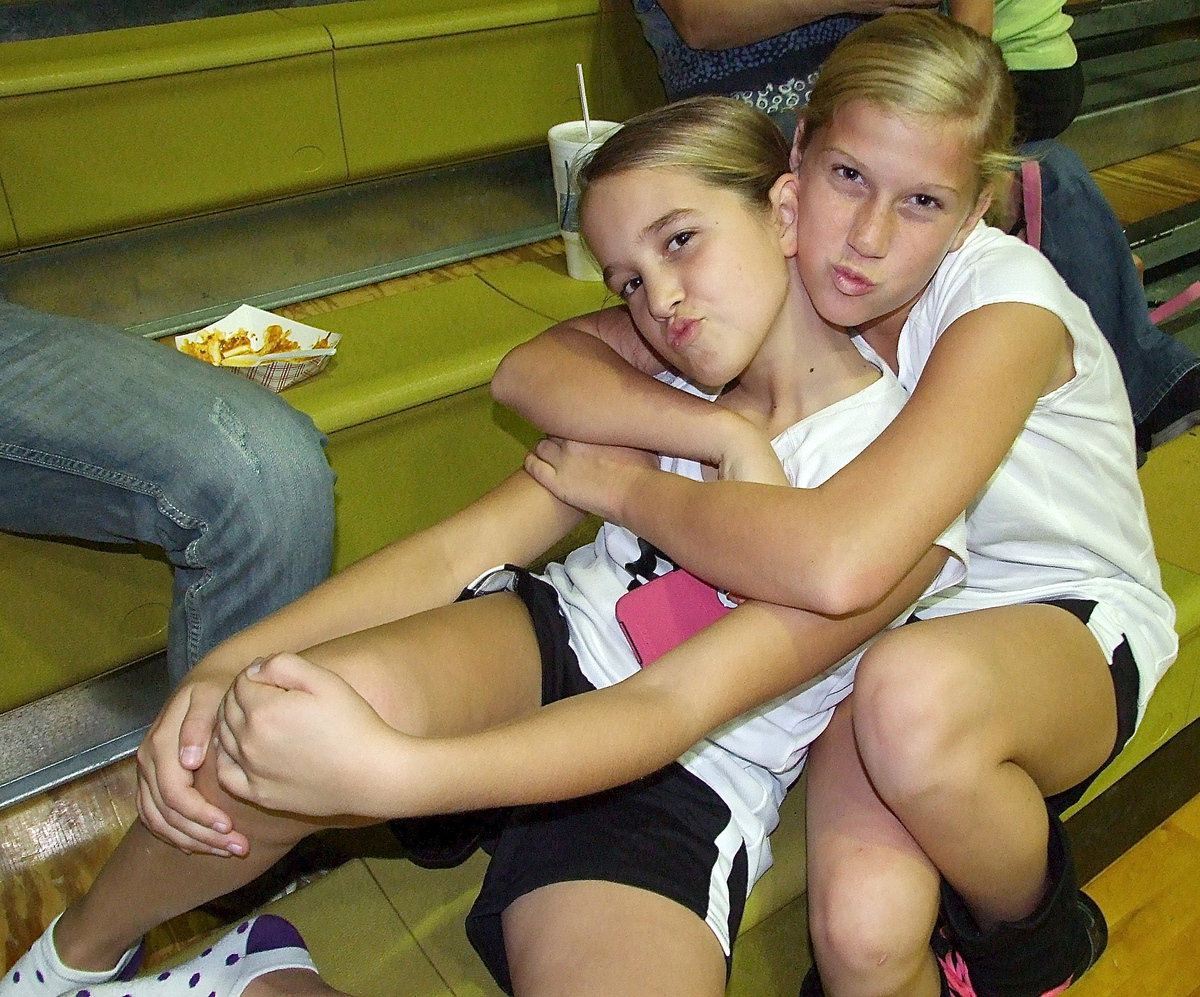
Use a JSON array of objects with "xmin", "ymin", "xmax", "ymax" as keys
[{"xmin": 1020, "ymin": 140, "xmax": 1200, "ymax": 424}]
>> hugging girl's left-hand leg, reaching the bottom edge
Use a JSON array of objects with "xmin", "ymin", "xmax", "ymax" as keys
[{"xmin": 805, "ymin": 695, "xmax": 938, "ymax": 997}]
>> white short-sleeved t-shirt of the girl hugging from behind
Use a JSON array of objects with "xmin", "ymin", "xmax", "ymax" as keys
[{"xmin": 854, "ymin": 223, "xmax": 1178, "ymax": 721}]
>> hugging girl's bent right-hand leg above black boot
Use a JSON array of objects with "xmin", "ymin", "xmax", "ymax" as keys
[{"xmin": 854, "ymin": 606, "xmax": 1116, "ymax": 927}]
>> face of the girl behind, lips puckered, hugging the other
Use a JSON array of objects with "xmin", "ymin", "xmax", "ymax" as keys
[{"xmin": 797, "ymin": 100, "xmax": 990, "ymax": 336}]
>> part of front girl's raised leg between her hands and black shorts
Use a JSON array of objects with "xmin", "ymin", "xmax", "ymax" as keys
[{"xmin": 304, "ymin": 591, "xmax": 542, "ymax": 737}]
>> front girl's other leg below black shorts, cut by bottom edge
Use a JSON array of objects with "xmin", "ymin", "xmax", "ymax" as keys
[{"xmin": 504, "ymin": 881, "xmax": 726, "ymax": 997}]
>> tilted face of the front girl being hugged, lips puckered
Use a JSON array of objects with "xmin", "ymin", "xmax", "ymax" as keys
[{"xmin": 582, "ymin": 167, "xmax": 794, "ymax": 388}]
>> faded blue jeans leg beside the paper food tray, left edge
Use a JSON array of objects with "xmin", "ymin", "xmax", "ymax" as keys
[{"xmin": 0, "ymin": 299, "xmax": 334, "ymax": 680}]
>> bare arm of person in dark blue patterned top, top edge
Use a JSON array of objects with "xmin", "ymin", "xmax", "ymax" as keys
[{"xmin": 660, "ymin": 0, "xmax": 936, "ymax": 49}]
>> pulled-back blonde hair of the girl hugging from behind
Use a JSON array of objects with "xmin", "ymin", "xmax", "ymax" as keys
[{"xmin": 799, "ymin": 11, "xmax": 1019, "ymax": 194}]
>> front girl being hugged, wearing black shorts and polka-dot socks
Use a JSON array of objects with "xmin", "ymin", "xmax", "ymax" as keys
[{"xmin": 0, "ymin": 98, "xmax": 965, "ymax": 997}]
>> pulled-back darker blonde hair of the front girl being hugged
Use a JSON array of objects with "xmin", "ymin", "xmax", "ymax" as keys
[{"xmin": 580, "ymin": 96, "xmax": 791, "ymax": 210}]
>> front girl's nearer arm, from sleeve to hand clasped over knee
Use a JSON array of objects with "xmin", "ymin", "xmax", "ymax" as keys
[{"xmin": 218, "ymin": 551, "xmax": 944, "ymax": 817}]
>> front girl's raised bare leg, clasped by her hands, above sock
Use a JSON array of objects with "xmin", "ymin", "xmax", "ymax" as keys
[{"xmin": 55, "ymin": 594, "xmax": 541, "ymax": 969}]
